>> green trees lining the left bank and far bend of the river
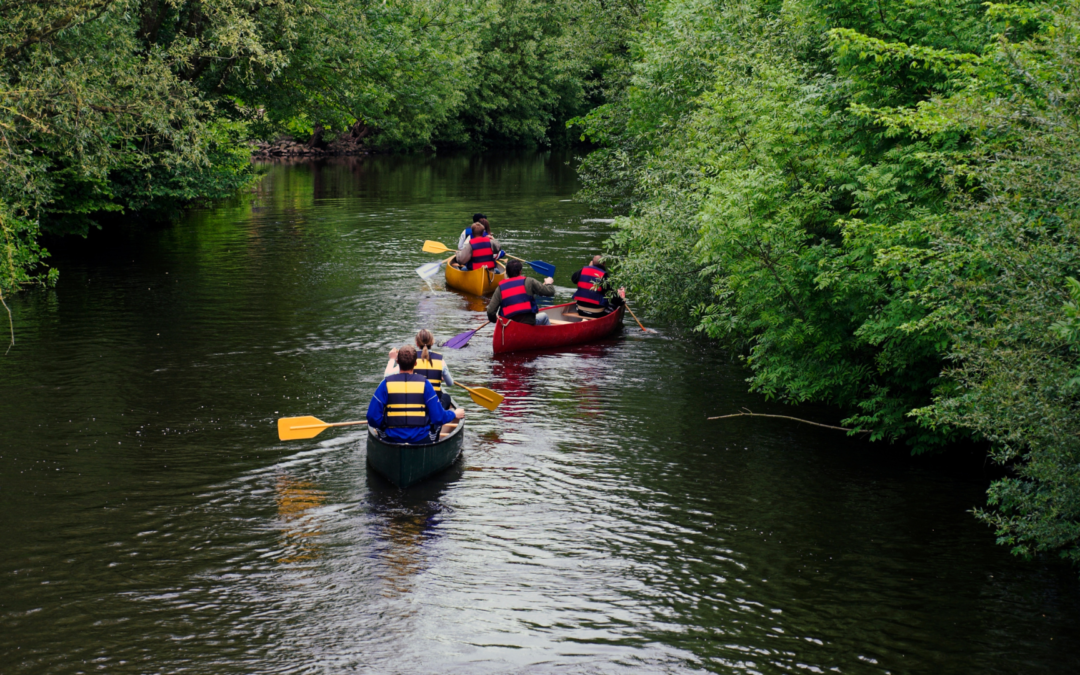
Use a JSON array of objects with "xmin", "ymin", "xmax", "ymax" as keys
[{"xmin": 0, "ymin": 0, "xmax": 638, "ymax": 293}]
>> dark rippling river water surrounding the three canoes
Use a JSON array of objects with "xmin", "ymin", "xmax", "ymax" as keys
[{"xmin": 0, "ymin": 154, "xmax": 1080, "ymax": 675}]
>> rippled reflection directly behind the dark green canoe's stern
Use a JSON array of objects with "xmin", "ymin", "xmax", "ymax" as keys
[{"xmin": 367, "ymin": 462, "xmax": 462, "ymax": 597}]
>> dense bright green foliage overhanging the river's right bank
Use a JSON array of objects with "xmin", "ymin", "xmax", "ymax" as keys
[{"xmin": 578, "ymin": 0, "xmax": 1080, "ymax": 559}]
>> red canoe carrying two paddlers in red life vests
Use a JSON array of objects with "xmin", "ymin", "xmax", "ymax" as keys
[{"xmin": 491, "ymin": 302, "xmax": 625, "ymax": 354}]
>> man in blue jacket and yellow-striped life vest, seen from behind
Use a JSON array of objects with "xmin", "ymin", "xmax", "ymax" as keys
[{"xmin": 367, "ymin": 345, "xmax": 465, "ymax": 445}]
